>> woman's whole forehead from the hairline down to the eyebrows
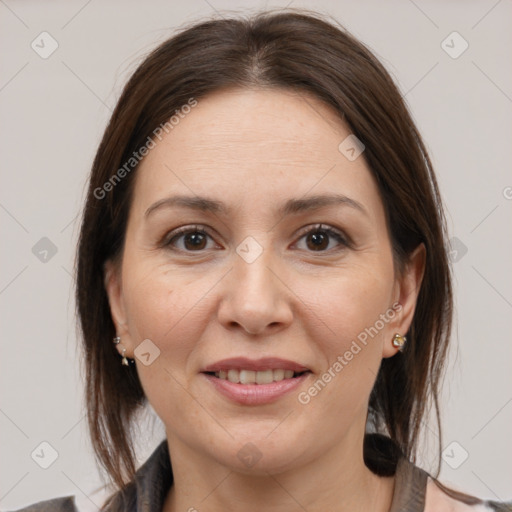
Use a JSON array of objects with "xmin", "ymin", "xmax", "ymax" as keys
[{"xmin": 130, "ymin": 85, "xmax": 379, "ymax": 213}]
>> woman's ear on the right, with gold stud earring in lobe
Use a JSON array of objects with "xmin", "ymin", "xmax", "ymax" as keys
[{"xmin": 382, "ymin": 243, "xmax": 427, "ymax": 357}]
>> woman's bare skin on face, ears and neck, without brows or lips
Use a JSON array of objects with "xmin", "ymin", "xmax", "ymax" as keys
[{"xmin": 105, "ymin": 89, "xmax": 425, "ymax": 512}]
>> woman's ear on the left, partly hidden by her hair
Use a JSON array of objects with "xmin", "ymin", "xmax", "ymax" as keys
[{"xmin": 103, "ymin": 260, "xmax": 133, "ymax": 357}]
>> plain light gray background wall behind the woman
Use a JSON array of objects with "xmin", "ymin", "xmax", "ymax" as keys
[{"xmin": 0, "ymin": 0, "xmax": 512, "ymax": 510}]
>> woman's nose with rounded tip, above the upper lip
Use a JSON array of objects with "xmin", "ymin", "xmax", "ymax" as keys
[{"xmin": 218, "ymin": 249, "xmax": 293, "ymax": 335}]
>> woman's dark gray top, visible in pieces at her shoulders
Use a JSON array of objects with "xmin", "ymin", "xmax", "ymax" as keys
[{"xmin": 8, "ymin": 440, "xmax": 512, "ymax": 512}]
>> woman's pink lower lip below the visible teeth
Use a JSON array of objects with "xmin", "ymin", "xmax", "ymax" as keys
[{"xmin": 201, "ymin": 372, "xmax": 309, "ymax": 405}]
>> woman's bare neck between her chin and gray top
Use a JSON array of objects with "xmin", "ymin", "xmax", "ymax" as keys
[{"xmin": 163, "ymin": 430, "xmax": 394, "ymax": 512}]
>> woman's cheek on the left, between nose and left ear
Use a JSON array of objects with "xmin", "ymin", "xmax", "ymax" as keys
[{"xmin": 123, "ymin": 265, "xmax": 215, "ymax": 425}]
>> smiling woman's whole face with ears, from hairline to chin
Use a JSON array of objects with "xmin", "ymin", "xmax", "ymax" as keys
[{"xmin": 106, "ymin": 89, "xmax": 422, "ymax": 472}]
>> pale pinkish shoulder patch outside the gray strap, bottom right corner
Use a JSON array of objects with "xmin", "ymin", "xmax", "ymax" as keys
[{"xmin": 424, "ymin": 475, "xmax": 512, "ymax": 512}]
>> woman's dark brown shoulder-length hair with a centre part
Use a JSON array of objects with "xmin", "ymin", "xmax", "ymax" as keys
[{"xmin": 76, "ymin": 11, "xmax": 460, "ymax": 508}]
